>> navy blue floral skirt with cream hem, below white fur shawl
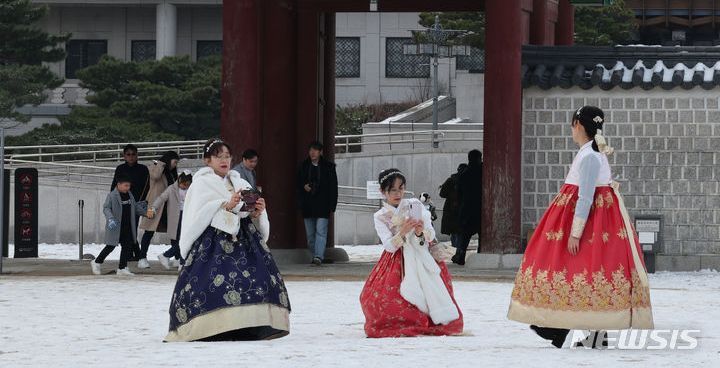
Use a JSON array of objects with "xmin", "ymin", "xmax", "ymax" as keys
[{"xmin": 165, "ymin": 218, "xmax": 290, "ymax": 341}]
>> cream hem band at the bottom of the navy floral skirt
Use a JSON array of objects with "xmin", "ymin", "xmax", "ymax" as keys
[{"xmin": 164, "ymin": 304, "xmax": 290, "ymax": 342}]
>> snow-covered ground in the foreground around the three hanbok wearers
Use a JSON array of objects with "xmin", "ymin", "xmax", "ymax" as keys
[{"xmin": 0, "ymin": 271, "xmax": 720, "ymax": 368}]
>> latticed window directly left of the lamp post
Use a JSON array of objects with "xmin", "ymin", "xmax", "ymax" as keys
[{"xmin": 385, "ymin": 37, "xmax": 430, "ymax": 78}]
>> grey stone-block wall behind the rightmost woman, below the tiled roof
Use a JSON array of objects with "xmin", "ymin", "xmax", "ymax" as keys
[{"xmin": 522, "ymin": 87, "xmax": 720, "ymax": 258}]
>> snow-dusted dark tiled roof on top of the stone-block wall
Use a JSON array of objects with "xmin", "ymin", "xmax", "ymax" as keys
[{"xmin": 521, "ymin": 46, "xmax": 720, "ymax": 90}]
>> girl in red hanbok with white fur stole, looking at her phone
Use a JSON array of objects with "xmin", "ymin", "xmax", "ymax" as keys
[{"xmin": 360, "ymin": 169, "xmax": 463, "ymax": 337}]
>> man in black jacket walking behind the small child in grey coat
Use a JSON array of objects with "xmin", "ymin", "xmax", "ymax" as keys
[{"xmin": 110, "ymin": 144, "xmax": 150, "ymax": 261}]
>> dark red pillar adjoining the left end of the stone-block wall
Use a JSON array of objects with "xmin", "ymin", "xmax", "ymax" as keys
[{"xmin": 481, "ymin": 0, "xmax": 523, "ymax": 253}]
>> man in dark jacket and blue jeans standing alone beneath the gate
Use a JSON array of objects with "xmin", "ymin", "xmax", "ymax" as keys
[{"xmin": 296, "ymin": 142, "xmax": 338, "ymax": 265}]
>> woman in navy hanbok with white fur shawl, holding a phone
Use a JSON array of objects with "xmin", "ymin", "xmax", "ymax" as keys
[{"xmin": 165, "ymin": 139, "xmax": 290, "ymax": 341}]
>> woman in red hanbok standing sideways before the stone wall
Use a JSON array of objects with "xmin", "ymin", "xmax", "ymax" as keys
[{"xmin": 508, "ymin": 106, "xmax": 653, "ymax": 348}]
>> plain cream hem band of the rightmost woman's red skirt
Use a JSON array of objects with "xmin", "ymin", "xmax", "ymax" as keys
[{"xmin": 508, "ymin": 300, "xmax": 653, "ymax": 330}]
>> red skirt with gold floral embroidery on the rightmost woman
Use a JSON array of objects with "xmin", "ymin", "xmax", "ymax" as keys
[{"xmin": 508, "ymin": 184, "xmax": 653, "ymax": 330}]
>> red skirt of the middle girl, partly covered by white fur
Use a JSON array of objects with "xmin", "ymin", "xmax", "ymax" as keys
[{"xmin": 360, "ymin": 251, "xmax": 463, "ymax": 337}]
